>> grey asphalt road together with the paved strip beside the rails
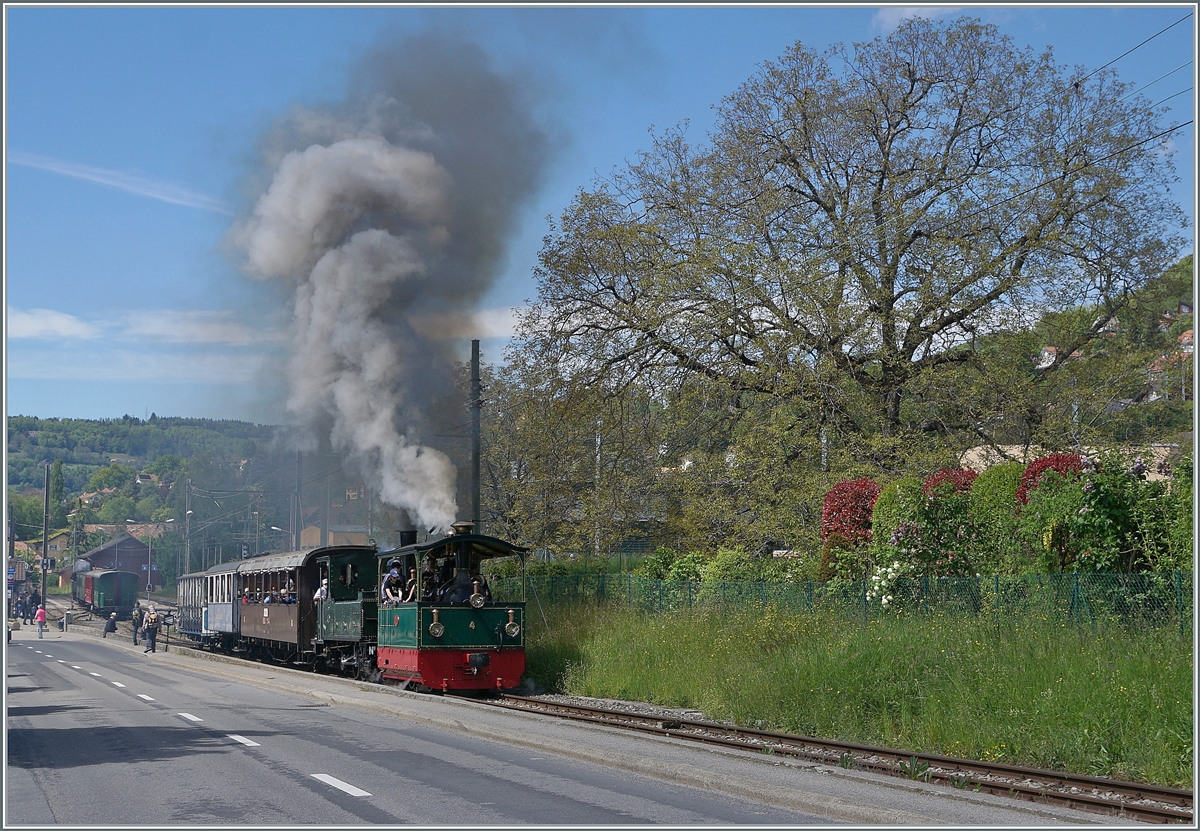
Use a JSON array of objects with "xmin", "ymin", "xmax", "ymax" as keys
[{"xmin": 4, "ymin": 627, "xmax": 1122, "ymax": 827}]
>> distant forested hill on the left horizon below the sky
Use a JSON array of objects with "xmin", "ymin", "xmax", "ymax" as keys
[{"xmin": 7, "ymin": 416, "xmax": 278, "ymax": 494}]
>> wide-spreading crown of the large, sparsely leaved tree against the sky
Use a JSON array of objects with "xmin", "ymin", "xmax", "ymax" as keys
[{"xmin": 522, "ymin": 18, "xmax": 1182, "ymax": 454}]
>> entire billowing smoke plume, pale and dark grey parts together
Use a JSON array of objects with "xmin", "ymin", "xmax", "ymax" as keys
[{"xmin": 229, "ymin": 35, "xmax": 548, "ymax": 527}]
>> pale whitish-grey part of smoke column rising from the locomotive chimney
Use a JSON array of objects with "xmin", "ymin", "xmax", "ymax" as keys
[{"xmin": 233, "ymin": 136, "xmax": 456, "ymax": 527}]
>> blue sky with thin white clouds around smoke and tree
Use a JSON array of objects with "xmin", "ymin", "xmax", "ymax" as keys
[{"xmin": 5, "ymin": 5, "xmax": 1195, "ymax": 423}]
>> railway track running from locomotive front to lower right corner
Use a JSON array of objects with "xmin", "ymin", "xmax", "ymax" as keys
[{"xmin": 484, "ymin": 695, "xmax": 1193, "ymax": 824}]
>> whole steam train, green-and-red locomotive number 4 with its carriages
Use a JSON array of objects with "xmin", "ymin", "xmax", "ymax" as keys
[{"xmin": 176, "ymin": 522, "xmax": 527, "ymax": 690}]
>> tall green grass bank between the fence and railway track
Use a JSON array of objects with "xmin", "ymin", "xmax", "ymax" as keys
[{"xmin": 528, "ymin": 604, "xmax": 1193, "ymax": 788}]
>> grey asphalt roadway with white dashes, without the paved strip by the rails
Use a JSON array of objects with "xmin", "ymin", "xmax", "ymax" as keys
[{"xmin": 5, "ymin": 628, "xmax": 832, "ymax": 827}]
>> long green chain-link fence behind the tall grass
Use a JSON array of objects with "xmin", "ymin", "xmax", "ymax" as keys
[{"xmin": 492, "ymin": 572, "xmax": 1193, "ymax": 632}]
